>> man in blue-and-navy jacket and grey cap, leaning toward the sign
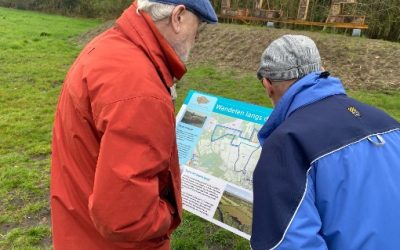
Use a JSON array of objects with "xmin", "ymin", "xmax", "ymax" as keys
[{"xmin": 251, "ymin": 35, "xmax": 400, "ymax": 250}]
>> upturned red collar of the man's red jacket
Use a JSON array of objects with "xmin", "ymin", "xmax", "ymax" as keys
[{"xmin": 116, "ymin": 2, "xmax": 186, "ymax": 87}]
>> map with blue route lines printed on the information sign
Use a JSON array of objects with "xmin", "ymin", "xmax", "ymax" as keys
[{"xmin": 188, "ymin": 113, "xmax": 261, "ymax": 190}]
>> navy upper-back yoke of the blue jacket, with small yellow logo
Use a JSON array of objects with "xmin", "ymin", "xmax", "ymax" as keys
[{"xmin": 266, "ymin": 95, "xmax": 400, "ymax": 160}]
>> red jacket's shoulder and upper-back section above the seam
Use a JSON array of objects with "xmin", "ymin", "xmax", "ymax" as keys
[{"xmin": 66, "ymin": 28, "xmax": 172, "ymax": 120}]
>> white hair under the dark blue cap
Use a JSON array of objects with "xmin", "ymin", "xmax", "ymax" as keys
[{"xmin": 138, "ymin": 0, "xmax": 175, "ymax": 22}]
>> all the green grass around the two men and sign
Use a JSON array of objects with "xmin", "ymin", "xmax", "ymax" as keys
[{"xmin": 0, "ymin": 8, "xmax": 400, "ymax": 249}]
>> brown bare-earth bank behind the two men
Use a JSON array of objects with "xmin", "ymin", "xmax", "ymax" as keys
[{"xmin": 79, "ymin": 21, "xmax": 400, "ymax": 91}]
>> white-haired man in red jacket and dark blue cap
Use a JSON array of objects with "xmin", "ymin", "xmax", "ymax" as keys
[{"xmin": 51, "ymin": 0, "xmax": 217, "ymax": 250}]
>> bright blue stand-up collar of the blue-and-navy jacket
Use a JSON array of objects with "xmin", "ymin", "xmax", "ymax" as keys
[{"xmin": 258, "ymin": 72, "xmax": 346, "ymax": 145}]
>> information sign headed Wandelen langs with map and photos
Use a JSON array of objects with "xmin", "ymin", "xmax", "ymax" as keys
[{"xmin": 176, "ymin": 91, "xmax": 272, "ymax": 239}]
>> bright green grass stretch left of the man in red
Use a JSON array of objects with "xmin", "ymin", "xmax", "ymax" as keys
[{"xmin": 0, "ymin": 8, "xmax": 99, "ymax": 249}]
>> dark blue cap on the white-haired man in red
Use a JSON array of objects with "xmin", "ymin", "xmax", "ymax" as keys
[{"xmin": 149, "ymin": 0, "xmax": 218, "ymax": 23}]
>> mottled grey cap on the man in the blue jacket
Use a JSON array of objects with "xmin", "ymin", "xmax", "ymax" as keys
[{"xmin": 257, "ymin": 35, "xmax": 321, "ymax": 81}]
